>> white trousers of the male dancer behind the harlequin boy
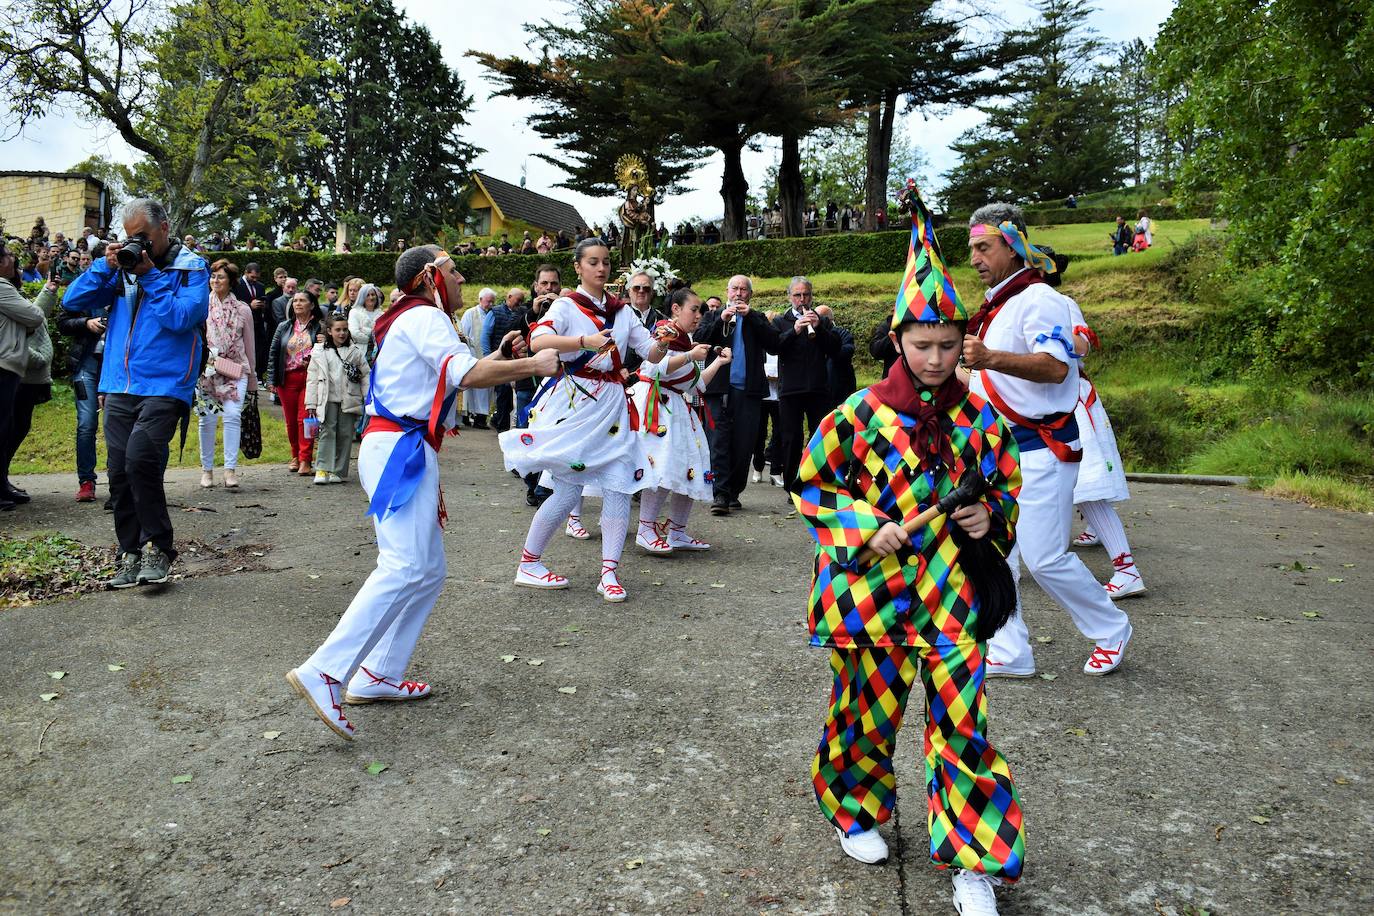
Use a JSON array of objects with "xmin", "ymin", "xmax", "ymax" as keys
[{"xmin": 988, "ymin": 449, "xmax": 1131, "ymax": 669}]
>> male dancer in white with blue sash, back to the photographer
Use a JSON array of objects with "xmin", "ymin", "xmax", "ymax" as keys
[{"xmin": 286, "ymin": 244, "xmax": 558, "ymax": 739}]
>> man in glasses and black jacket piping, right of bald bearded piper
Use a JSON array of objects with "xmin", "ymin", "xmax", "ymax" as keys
[{"xmin": 774, "ymin": 276, "xmax": 852, "ymax": 489}]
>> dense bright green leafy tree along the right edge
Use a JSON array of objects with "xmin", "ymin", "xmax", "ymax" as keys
[{"xmin": 1156, "ymin": 0, "xmax": 1374, "ymax": 385}]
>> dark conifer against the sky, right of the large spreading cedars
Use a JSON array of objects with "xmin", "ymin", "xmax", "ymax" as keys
[{"xmin": 945, "ymin": 0, "xmax": 1131, "ymax": 209}]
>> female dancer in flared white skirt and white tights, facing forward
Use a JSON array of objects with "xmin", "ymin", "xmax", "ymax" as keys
[{"xmin": 500, "ymin": 238, "xmax": 668, "ymax": 602}]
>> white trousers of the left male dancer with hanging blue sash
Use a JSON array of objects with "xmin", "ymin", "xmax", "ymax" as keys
[{"xmin": 306, "ymin": 433, "xmax": 448, "ymax": 684}]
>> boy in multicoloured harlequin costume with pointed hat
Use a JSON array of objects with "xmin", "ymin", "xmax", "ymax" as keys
[{"xmin": 793, "ymin": 189, "xmax": 1025, "ymax": 915}]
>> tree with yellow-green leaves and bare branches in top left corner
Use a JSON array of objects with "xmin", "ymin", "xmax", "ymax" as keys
[{"xmin": 0, "ymin": 0, "xmax": 322, "ymax": 232}]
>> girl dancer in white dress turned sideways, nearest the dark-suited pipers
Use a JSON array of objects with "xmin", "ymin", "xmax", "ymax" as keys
[{"xmin": 633, "ymin": 288, "xmax": 730, "ymax": 556}]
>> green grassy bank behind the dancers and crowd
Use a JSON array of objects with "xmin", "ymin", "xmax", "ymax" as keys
[{"xmin": 14, "ymin": 220, "xmax": 1374, "ymax": 511}]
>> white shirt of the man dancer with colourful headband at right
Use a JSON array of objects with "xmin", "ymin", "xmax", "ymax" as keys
[{"xmin": 969, "ymin": 268, "xmax": 1081, "ymax": 420}]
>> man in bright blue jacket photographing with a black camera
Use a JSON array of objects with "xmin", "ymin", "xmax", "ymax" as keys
[{"xmin": 62, "ymin": 198, "xmax": 210, "ymax": 588}]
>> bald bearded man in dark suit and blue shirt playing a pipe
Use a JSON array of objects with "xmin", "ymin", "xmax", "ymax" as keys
[{"xmin": 694, "ymin": 275, "xmax": 778, "ymax": 515}]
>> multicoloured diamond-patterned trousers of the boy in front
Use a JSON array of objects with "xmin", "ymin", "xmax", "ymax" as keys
[{"xmin": 811, "ymin": 641, "xmax": 1025, "ymax": 882}]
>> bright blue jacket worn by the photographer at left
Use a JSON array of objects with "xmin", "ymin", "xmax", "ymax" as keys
[{"xmin": 62, "ymin": 249, "xmax": 210, "ymax": 404}]
